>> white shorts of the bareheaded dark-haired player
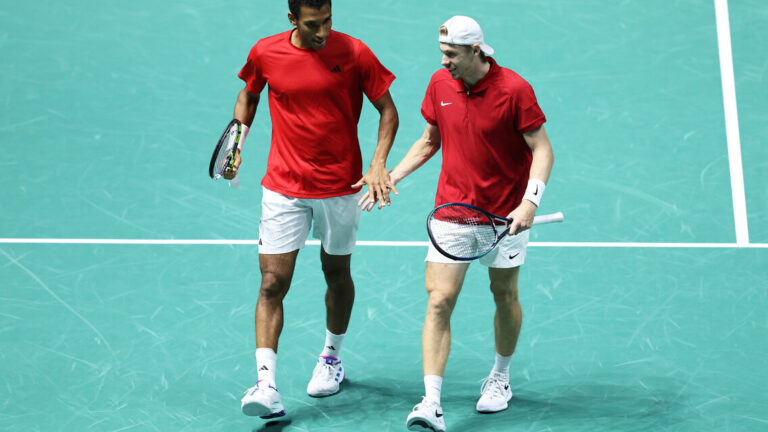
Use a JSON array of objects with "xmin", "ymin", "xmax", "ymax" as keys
[{"xmin": 259, "ymin": 186, "xmax": 363, "ymax": 255}]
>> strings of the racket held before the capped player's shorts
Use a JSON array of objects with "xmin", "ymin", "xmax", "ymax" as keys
[{"xmin": 429, "ymin": 206, "xmax": 503, "ymax": 258}]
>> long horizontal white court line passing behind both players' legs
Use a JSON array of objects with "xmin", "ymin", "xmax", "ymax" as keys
[{"xmin": 0, "ymin": 238, "xmax": 768, "ymax": 249}]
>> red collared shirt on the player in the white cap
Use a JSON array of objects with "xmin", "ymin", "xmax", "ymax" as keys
[{"xmin": 421, "ymin": 57, "xmax": 546, "ymax": 216}]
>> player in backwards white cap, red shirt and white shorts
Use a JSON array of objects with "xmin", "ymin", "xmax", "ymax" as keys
[{"xmin": 361, "ymin": 16, "xmax": 554, "ymax": 431}]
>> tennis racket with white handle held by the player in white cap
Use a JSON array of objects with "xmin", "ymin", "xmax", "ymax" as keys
[{"xmin": 427, "ymin": 203, "xmax": 563, "ymax": 261}]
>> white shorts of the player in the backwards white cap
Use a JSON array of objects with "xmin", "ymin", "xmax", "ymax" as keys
[{"xmin": 424, "ymin": 226, "xmax": 530, "ymax": 268}]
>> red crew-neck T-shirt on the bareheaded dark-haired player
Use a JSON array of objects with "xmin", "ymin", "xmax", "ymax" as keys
[{"xmin": 238, "ymin": 30, "xmax": 395, "ymax": 198}]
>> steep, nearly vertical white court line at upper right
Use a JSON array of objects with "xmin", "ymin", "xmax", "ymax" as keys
[{"xmin": 715, "ymin": 0, "xmax": 749, "ymax": 245}]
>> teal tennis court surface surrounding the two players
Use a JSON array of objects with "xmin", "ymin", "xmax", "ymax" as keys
[{"xmin": 0, "ymin": 0, "xmax": 768, "ymax": 432}]
